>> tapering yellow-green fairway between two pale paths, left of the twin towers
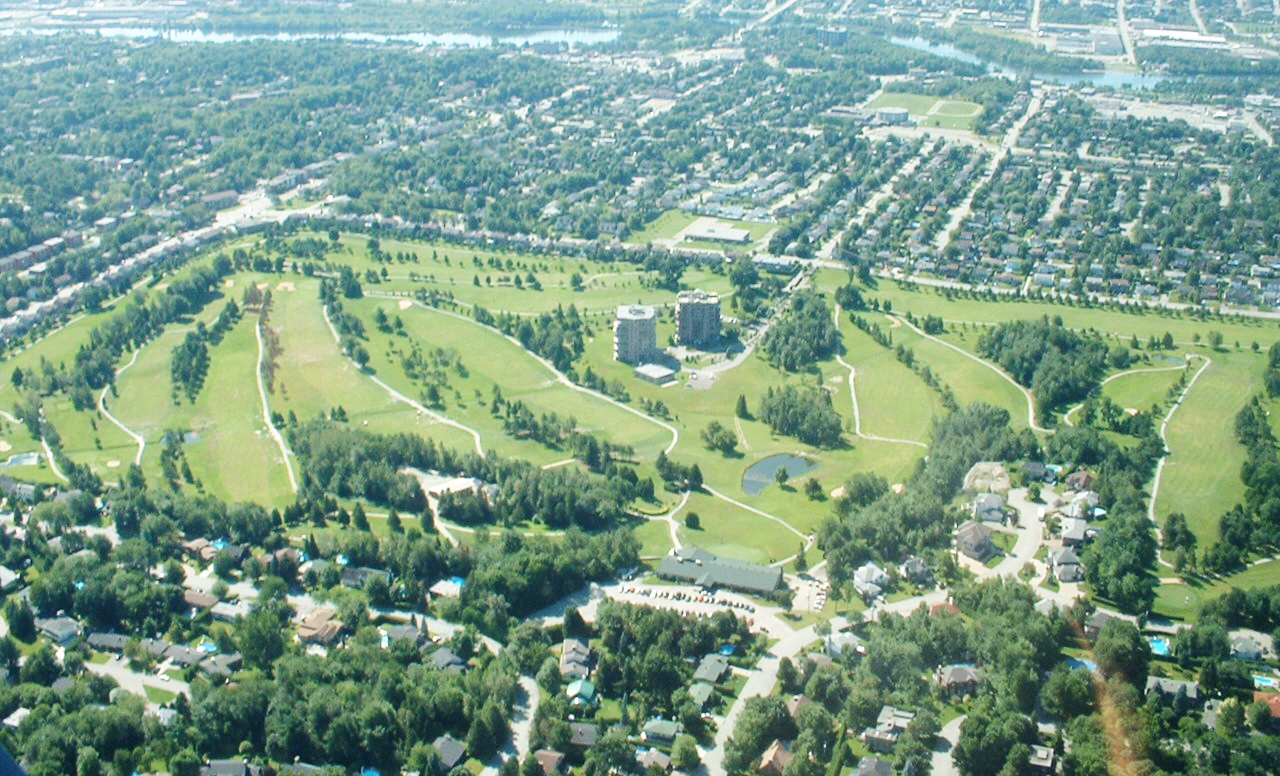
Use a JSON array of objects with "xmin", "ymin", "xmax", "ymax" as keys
[{"xmin": 270, "ymin": 279, "xmax": 472, "ymax": 449}]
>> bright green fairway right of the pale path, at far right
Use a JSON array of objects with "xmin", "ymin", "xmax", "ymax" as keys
[{"xmin": 1156, "ymin": 352, "xmax": 1265, "ymax": 547}]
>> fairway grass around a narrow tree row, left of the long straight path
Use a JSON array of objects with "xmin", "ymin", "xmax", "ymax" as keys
[{"xmin": 108, "ymin": 303, "xmax": 292, "ymax": 514}]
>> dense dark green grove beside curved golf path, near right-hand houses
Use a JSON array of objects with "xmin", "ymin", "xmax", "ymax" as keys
[{"xmin": 978, "ymin": 316, "xmax": 1107, "ymax": 421}]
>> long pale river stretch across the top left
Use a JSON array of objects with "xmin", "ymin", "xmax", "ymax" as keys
[{"xmin": 0, "ymin": 27, "xmax": 621, "ymax": 49}]
